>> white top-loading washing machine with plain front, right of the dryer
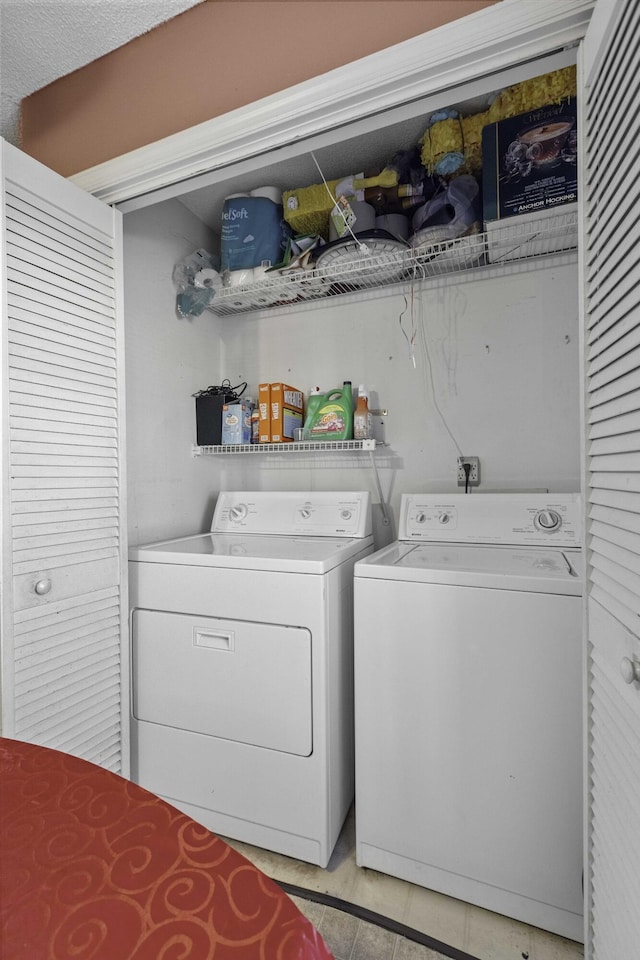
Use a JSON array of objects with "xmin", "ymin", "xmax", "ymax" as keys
[{"xmin": 354, "ymin": 494, "xmax": 583, "ymax": 940}]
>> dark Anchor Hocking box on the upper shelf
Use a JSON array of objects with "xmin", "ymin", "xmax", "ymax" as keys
[{"xmin": 482, "ymin": 97, "xmax": 578, "ymax": 222}]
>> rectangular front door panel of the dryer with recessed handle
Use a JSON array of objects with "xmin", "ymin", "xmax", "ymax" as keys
[{"xmin": 132, "ymin": 610, "xmax": 312, "ymax": 756}]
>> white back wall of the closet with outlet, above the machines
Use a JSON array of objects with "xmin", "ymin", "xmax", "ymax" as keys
[{"xmin": 211, "ymin": 262, "xmax": 580, "ymax": 540}]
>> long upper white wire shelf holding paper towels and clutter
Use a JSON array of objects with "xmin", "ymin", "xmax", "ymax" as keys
[{"xmin": 209, "ymin": 206, "xmax": 578, "ymax": 317}]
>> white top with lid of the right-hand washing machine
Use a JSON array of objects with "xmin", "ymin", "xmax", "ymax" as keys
[{"xmin": 355, "ymin": 543, "xmax": 583, "ymax": 596}]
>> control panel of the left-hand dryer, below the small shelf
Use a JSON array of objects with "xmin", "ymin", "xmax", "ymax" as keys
[{"xmin": 211, "ymin": 491, "xmax": 371, "ymax": 537}]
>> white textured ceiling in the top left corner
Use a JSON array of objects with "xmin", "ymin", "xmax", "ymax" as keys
[{"xmin": 0, "ymin": 0, "xmax": 202, "ymax": 144}]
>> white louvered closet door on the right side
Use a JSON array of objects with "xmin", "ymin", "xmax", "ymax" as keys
[{"xmin": 583, "ymin": 0, "xmax": 640, "ymax": 960}]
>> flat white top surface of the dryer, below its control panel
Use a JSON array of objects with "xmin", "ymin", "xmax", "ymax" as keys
[{"xmin": 129, "ymin": 533, "xmax": 373, "ymax": 574}]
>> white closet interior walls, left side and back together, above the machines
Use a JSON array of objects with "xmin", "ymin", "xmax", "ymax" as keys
[{"xmin": 125, "ymin": 201, "xmax": 580, "ymax": 545}]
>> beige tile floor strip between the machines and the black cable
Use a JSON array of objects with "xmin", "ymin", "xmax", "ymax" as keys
[{"xmin": 225, "ymin": 812, "xmax": 584, "ymax": 960}]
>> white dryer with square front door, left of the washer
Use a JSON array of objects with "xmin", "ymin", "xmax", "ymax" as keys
[{"xmin": 129, "ymin": 492, "xmax": 373, "ymax": 866}]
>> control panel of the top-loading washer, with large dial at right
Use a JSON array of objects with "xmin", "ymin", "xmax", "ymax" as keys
[{"xmin": 398, "ymin": 493, "xmax": 582, "ymax": 547}]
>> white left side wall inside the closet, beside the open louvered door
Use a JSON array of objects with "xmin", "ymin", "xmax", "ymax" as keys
[{"xmin": 124, "ymin": 201, "xmax": 226, "ymax": 546}]
